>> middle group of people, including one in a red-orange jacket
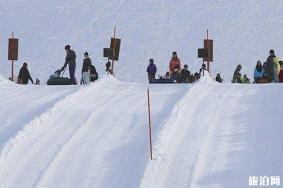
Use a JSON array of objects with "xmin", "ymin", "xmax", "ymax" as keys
[{"xmin": 147, "ymin": 52, "xmax": 223, "ymax": 83}]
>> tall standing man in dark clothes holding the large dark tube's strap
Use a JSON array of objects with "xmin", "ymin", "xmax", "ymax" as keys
[{"xmin": 61, "ymin": 45, "xmax": 77, "ymax": 85}]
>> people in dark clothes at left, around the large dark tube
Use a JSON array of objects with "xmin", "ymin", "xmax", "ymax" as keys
[{"xmin": 17, "ymin": 45, "xmax": 98, "ymax": 85}]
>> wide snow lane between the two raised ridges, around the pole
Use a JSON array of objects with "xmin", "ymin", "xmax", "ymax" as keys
[{"xmin": 0, "ymin": 75, "xmax": 191, "ymax": 188}]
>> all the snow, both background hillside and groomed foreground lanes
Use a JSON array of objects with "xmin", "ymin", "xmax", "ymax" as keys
[{"xmin": 0, "ymin": 0, "xmax": 283, "ymax": 188}]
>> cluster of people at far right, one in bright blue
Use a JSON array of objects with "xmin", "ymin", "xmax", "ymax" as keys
[{"xmin": 232, "ymin": 50, "xmax": 283, "ymax": 83}]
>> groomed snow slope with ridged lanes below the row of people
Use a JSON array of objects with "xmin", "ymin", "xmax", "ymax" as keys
[{"xmin": 0, "ymin": 76, "xmax": 283, "ymax": 188}]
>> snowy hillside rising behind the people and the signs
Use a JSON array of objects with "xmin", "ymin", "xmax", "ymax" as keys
[{"xmin": 0, "ymin": 0, "xmax": 283, "ymax": 82}]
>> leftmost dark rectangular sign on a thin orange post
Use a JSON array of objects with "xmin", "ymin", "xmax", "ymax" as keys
[{"xmin": 8, "ymin": 33, "xmax": 19, "ymax": 81}]
